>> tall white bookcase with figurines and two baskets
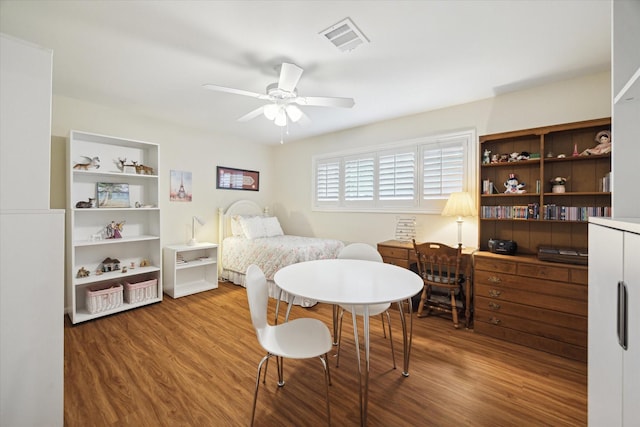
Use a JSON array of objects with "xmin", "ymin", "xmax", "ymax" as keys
[{"xmin": 67, "ymin": 131, "xmax": 162, "ymax": 323}]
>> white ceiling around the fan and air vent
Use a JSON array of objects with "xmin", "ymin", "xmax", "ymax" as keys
[{"xmin": 0, "ymin": 0, "xmax": 611, "ymax": 144}]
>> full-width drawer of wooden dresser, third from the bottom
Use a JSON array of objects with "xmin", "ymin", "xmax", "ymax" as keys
[{"xmin": 474, "ymin": 282, "xmax": 588, "ymax": 316}]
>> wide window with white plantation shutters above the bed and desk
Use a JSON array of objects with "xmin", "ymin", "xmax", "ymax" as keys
[{"xmin": 313, "ymin": 131, "xmax": 477, "ymax": 213}]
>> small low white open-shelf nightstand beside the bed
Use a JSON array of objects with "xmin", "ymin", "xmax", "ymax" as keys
[{"xmin": 164, "ymin": 243, "xmax": 218, "ymax": 298}]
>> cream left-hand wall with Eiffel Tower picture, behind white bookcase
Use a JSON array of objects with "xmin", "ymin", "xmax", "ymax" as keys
[{"xmin": 51, "ymin": 96, "xmax": 274, "ymax": 246}]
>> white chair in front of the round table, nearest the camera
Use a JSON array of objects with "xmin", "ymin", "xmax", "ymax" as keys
[{"xmin": 246, "ymin": 264, "xmax": 332, "ymax": 425}]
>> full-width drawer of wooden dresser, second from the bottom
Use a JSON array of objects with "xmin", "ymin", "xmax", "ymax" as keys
[{"xmin": 475, "ymin": 296, "xmax": 588, "ymax": 333}]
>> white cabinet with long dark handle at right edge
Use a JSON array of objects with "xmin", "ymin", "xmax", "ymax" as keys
[{"xmin": 588, "ymin": 218, "xmax": 640, "ymax": 427}]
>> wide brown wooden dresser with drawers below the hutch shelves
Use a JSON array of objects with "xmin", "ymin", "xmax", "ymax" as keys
[{"xmin": 474, "ymin": 251, "xmax": 588, "ymax": 362}]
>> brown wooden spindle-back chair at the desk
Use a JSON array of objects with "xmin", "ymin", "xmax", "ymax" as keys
[{"xmin": 413, "ymin": 240, "xmax": 465, "ymax": 329}]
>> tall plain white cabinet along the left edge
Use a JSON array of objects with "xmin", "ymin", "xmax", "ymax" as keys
[{"xmin": 0, "ymin": 34, "xmax": 64, "ymax": 427}]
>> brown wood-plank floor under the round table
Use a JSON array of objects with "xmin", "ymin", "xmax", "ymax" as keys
[{"xmin": 64, "ymin": 283, "xmax": 587, "ymax": 427}]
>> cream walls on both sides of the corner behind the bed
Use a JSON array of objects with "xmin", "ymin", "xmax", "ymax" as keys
[{"xmin": 52, "ymin": 72, "xmax": 611, "ymax": 251}]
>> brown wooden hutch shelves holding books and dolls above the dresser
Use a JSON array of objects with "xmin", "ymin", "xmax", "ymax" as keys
[{"xmin": 478, "ymin": 118, "xmax": 611, "ymax": 254}]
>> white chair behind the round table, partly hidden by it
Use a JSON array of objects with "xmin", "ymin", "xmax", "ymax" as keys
[{"xmin": 333, "ymin": 243, "xmax": 396, "ymax": 369}]
